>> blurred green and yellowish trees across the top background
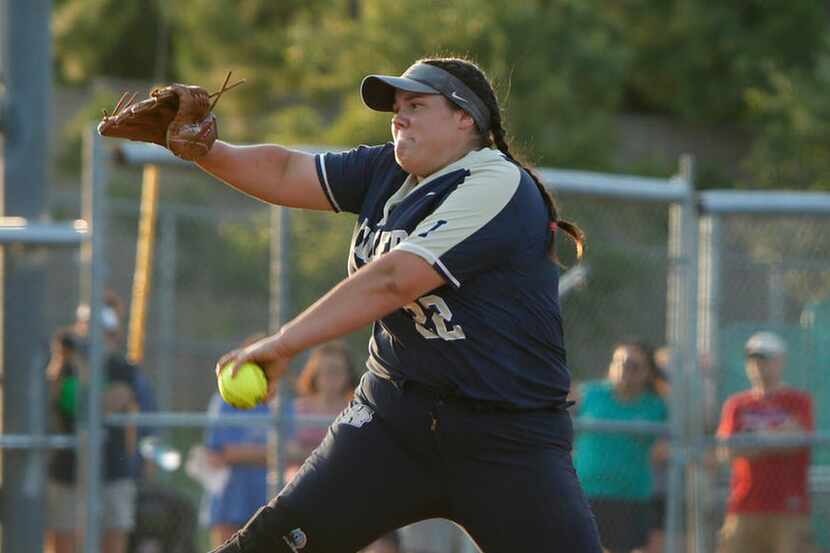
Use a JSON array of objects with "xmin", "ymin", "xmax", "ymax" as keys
[{"xmin": 53, "ymin": 0, "xmax": 830, "ymax": 187}]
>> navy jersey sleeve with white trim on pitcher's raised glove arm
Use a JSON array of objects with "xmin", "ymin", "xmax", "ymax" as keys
[{"xmin": 314, "ymin": 146, "xmax": 388, "ymax": 214}]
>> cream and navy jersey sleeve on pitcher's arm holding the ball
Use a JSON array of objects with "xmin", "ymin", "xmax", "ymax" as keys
[{"xmin": 394, "ymin": 163, "xmax": 522, "ymax": 288}]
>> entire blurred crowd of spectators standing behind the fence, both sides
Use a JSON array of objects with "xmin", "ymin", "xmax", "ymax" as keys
[{"xmin": 40, "ymin": 292, "xmax": 816, "ymax": 553}]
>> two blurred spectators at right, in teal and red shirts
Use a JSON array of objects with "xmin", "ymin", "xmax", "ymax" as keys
[{"xmin": 573, "ymin": 331, "xmax": 816, "ymax": 553}]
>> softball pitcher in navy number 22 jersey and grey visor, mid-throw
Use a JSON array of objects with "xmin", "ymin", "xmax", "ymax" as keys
[{"xmin": 102, "ymin": 54, "xmax": 601, "ymax": 553}]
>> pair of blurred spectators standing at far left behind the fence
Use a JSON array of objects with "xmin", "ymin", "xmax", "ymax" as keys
[{"xmin": 46, "ymin": 292, "xmax": 162, "ymax": 553}]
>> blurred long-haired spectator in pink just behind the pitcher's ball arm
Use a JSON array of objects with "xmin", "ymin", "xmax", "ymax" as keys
[{"xmin": 286, "ymin": 341, "xmax": 357, "ymax": 481}]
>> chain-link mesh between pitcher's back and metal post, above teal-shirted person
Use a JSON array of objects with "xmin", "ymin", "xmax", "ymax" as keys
[{"xmin": 552, "ymin": 193, "xmax": 669, "ymax": 381}]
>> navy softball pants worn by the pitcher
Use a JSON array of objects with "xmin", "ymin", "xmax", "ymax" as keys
[{"xmin": 215, "ymin": 374, "xmax": 602, "ymax": 553}]
